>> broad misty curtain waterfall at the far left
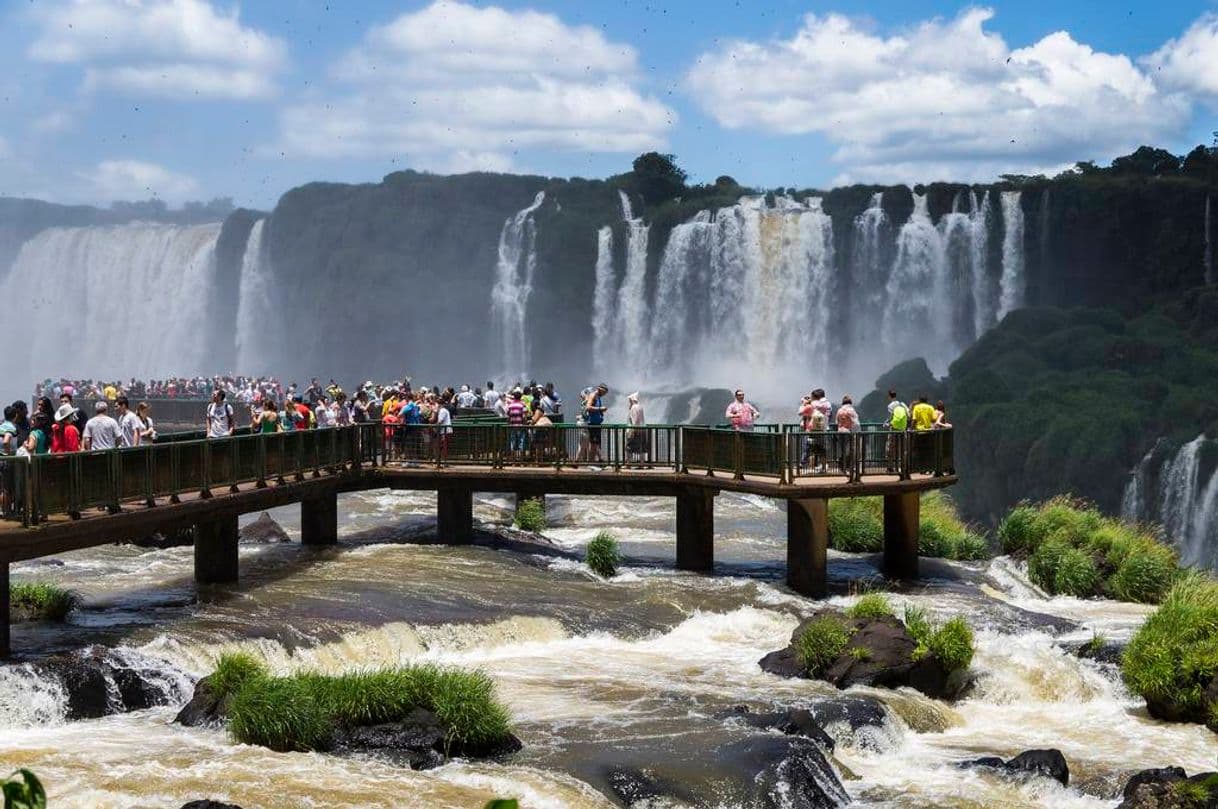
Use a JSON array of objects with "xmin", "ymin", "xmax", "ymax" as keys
[{"xmin": 0, "ymin": 223, "xmax": 221, "ymax": 385}]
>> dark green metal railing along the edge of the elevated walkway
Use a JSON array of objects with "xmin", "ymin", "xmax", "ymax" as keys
[{"xmin": 0, "ymin": 422, "xmax": 955, "ymax": 525}]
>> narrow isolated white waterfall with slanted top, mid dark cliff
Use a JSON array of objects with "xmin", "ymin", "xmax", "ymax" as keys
[{"xmin": 491, "ymin": 191, "xmax": 546, "ymax": 375}]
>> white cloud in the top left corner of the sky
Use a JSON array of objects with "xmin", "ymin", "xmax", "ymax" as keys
[{"xmin": 27, "ymin": 0, "xmax": 287, "ymax": 99}]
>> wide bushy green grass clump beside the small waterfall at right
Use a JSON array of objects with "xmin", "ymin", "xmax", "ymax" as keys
[{"xmin": 999, "ymin": 497, "xmax": 1179, "ymax": 603}]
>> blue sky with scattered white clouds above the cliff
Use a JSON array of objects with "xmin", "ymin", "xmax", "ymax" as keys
[{"xmin": 0, "ymin": 0, "xmax": 1218, "ymax": 208}]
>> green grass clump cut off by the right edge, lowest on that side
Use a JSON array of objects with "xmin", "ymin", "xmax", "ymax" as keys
[{"xmin": 1121, "ymin": 573, "xmax": 1218, "ymax": 727}]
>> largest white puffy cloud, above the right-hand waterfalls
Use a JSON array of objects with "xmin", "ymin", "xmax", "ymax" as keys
[{"xmin": 686, "ymin": 9, "xmax": 1198, "ymax": 182}]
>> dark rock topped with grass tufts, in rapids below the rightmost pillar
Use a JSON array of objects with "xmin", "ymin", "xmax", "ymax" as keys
[{"xmin": 758, "ymin": 610, "xmax": 967, "ymax": 699}]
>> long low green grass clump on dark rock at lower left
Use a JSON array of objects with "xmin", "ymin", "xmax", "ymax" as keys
[{"xmin": 221, "ymin": 665, "xmax": 510, "ymax": 751}]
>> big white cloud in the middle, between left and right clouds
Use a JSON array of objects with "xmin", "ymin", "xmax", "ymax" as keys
[{"xmin": 279, "ymin": 1, "xmax": 675, "ymax": 169}]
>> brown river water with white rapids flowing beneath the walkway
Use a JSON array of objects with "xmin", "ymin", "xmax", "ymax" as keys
[{"xmin": 0, "ymin": 492, "xmax": 1218, "ymax": 809}]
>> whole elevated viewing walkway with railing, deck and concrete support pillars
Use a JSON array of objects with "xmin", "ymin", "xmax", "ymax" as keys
[{"xmin": 0, "ymin": 423, "xmax": 956, "ymax": 657}]
